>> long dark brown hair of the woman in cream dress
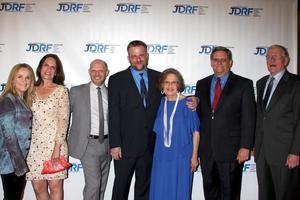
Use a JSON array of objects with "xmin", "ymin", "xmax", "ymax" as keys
[{"xmin": 34, "ymin": 54, "xmax": 65, "ymax": 86}]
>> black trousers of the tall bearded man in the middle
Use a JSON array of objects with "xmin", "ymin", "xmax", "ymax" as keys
[{"xmin": 112, "ymin": 151, "xmax": 153, "ymax": 200}]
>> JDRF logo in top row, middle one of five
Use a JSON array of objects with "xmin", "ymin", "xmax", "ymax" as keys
[{"xmin": 115, "ymin": 3, "xmax": 152, "ymax": 13}]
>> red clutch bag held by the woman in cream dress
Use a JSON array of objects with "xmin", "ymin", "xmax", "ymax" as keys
[{"xmin": 41, "ymin": 156, "xmax": 72, "ymax": 174}]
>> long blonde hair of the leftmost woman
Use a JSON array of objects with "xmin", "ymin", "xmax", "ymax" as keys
[{"xmin": 1, "ymin": 63, "xmax": 35, "ymax": 107}]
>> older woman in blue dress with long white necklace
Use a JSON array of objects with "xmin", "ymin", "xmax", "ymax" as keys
[{"xmin": 150, "ymin": 68, "xmax": 200, "ymax": 200}]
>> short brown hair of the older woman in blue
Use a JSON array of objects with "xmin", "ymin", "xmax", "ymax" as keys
[{"xmin": 157, "ymin": 68, "xmax": 185, "ymax": 92}]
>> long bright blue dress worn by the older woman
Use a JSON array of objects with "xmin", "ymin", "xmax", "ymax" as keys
[{"xmin": 150, "ymin": 98, "xmax": 200, "ymax": 200}]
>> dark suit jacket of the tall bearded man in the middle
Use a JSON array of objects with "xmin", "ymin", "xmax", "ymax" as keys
[{"xmin": 108, "ymin": 68, "xmax": 161, "ymax": 157}]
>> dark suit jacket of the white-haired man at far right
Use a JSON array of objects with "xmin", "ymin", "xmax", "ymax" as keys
[{"xmin": 255, "ymin": 71, "xmax": 300, "ymax": 165}]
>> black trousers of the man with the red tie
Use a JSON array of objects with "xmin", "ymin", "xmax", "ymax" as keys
[{"xmin": 200, "ymin": 156, "xmax": 244, "ymax": 200}]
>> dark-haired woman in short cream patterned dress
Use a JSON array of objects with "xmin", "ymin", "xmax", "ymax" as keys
[{"xmin": 26, "ymin": 54, "xmax": 69, "ymax": 200}]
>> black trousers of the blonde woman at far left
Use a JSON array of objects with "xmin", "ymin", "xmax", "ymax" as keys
[{"xmin": 1, "ymin": 173, "xmax": 26, "ymax": 200}]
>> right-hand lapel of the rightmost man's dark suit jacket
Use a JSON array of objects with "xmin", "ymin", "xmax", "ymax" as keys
[{"xmin": 266, "ymin": 71, "xmax": 289, "ymax": 112}]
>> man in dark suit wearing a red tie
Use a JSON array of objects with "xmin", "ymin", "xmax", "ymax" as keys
[{"xmin": 196, "ymin": 47, "xmax": 256, "ymax": 200}]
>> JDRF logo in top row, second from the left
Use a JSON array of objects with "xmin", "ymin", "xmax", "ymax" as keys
[{"xmin": 56, "ymin": 2, "xmax": 93, "ymax": 13}]
